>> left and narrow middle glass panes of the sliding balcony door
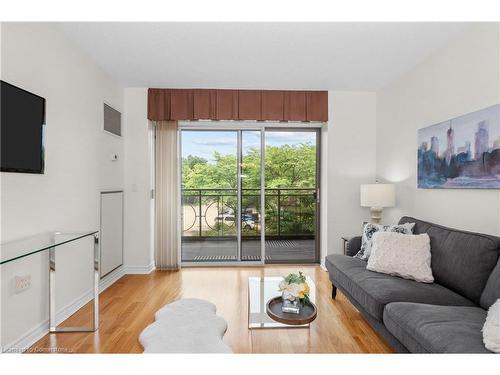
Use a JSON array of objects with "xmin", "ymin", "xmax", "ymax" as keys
[{"xmin": 181, "ymin": 130, "xmax": 262, "ymax": 262}]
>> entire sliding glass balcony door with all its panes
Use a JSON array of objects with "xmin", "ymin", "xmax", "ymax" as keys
[{"xmin": 180, "ymin": 128, "xmax": 319, "ymax": 263}]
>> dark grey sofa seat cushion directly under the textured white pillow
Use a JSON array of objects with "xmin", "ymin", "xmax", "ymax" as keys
[{"xmin": 326, "ymin": 254, "xmax": 474, "ymax": 321}]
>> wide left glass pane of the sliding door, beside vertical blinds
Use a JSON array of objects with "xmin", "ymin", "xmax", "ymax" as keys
[{"xmin": 181, "ymin": 131, "xmax": 238, "ymax": 262}]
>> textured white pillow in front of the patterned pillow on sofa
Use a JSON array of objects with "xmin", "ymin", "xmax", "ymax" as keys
[{"xmin": 366, "ymin": 232, "xmax": 434, "ymax": 283}]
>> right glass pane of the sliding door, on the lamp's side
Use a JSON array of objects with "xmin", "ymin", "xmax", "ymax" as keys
[{"xmin": 265, "ymin": 129, "xmax": 320, "ymax": 263}]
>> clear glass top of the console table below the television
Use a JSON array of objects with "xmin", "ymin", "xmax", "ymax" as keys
[{"xmin": 0, "ymin": 230, "xmax": 99, "ymax": 264}]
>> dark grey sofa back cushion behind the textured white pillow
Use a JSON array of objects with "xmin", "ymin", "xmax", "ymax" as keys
[{"xmin": 399, "ymin": 217, "xmax": 500, "ymax": 304}]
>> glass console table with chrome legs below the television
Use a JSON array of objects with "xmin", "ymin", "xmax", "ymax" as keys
[{"xmin": 0, "ymin": 231, "xmax": 100, "ymax": 332}]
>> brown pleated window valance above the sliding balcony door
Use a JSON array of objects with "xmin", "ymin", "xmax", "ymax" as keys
[{"xmin": 148, "ymin": 89, "xmax": 328, "ymax": 122}]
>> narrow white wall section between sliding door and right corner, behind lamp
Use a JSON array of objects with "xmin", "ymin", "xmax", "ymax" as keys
[{"xmin": 322, "ymin": 91, "xmax": 376, "ymax": 261}]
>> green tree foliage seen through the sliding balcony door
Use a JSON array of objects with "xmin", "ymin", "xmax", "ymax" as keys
[{"xmin": 182, "ymin": 143, "xmax": 316, "ymax": 235}]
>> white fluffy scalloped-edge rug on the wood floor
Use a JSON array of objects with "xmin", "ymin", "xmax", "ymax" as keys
[{"xmin": 139, "ymin": 298, "xmax": 232, "ymax": 353}]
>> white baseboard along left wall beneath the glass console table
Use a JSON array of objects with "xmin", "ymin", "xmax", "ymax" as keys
[{"xmin": 1, "ymin": 266, "xmax": 125, "ymax": 353}]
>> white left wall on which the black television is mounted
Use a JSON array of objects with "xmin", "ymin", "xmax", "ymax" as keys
[{"xmin": 0, "ymin": 23, "xmax": 124, "ymax": 352}]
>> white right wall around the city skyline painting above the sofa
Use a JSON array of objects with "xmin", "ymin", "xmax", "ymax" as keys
[{"xmin": 377, "ymin": 23, "xmax": 500, "ymax": 234}]
